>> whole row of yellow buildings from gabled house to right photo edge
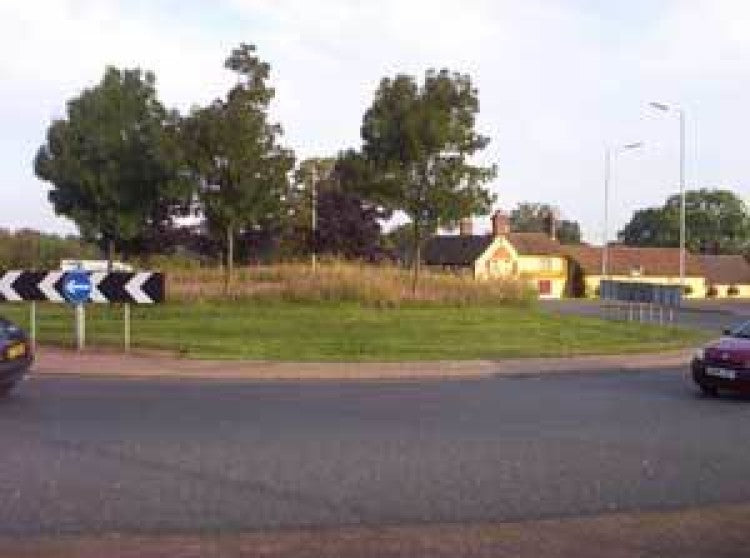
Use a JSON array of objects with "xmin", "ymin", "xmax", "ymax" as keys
[{"xmin": 422, "ymin": 212, "xmax": 750, "ymax": 298}]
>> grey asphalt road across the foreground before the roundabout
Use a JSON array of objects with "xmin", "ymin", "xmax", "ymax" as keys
[{"xmin": 0, "ymin": 370, "xmax": 750, "ymax": 536}]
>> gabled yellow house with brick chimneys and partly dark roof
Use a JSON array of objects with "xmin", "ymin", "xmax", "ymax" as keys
[{"xmin": 423, "ymin": 212, "xmax": 568, "ymax": 298}]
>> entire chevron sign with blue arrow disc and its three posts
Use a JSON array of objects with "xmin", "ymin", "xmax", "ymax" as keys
[{"xmin": 0, "ymin": 271, "xmax": 165, "ymax": 349}]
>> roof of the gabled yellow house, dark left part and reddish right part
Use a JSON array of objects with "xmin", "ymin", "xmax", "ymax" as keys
[{"xmin": 422, "ymin": 233, "xmax": 562, "ymax": 266}]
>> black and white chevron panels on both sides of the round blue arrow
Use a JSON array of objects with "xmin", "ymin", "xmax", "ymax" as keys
[{"xmin": 0, "ymin": 271, "xmax": 165, "ymax": 304}]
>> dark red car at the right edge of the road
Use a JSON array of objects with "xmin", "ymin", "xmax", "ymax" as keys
[{"xmin": 691, "ymin": 322, "xmax": 750, "ymax": 397}]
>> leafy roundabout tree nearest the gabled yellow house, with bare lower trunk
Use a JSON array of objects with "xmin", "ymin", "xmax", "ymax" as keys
[{"xmin": 362, "ymin": 70, "xmax": 496, "ymax": 290}]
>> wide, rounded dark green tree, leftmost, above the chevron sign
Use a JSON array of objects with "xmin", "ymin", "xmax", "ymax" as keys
[{"xmin": 34, "ymin": 67, "xmax": 184, "ymax": 262}]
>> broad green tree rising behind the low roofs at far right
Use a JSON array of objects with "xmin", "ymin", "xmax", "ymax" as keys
[{"xmin": 619, "ymin": 189, "xmax": 750, "ymax": 254}]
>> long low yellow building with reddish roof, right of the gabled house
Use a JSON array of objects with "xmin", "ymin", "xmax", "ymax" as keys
[{"xmin": 562, "ymin": 245, "xmax": 706, "ymax": 298}]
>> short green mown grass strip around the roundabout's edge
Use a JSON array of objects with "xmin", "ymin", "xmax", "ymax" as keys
[{"xmin": 0, "ymin": 301, "xmax": 704, "ymax": 361}]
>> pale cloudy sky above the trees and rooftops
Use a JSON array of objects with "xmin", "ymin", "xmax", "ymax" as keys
[{"xmin": 0, "ymin": 0, "xmax": 750, "ymax": 242}]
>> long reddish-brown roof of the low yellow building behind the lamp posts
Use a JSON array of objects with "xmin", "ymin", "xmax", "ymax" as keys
[{"xmin": 562, "ymin": 245, "xmax": 704, "ymax": 277}]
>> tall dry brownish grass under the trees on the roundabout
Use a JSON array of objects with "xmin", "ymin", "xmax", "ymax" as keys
[{"xmin": 167, "ymin": 261, "xmax": 536, "ymax": 306}]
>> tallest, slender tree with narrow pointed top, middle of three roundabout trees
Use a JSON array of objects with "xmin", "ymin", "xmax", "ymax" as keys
[{"xmin": 184, "ymin": 44, "xmax": 294, "ymax": 291}]
